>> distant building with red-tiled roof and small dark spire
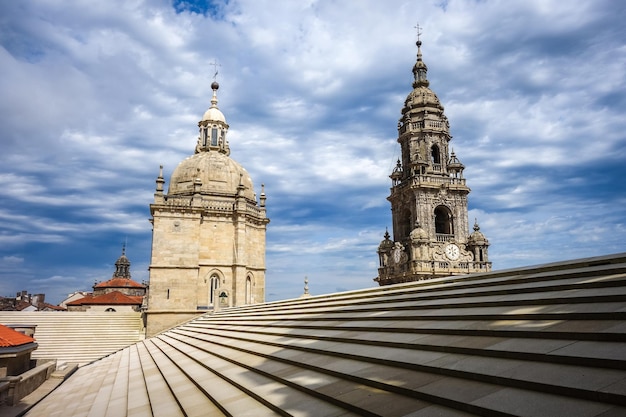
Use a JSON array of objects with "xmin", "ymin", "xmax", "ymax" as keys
[{"xmin": 65, "ymin": 248, "xmax": 146, "ymax": 312}]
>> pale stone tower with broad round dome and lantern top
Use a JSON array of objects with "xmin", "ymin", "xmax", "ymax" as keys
[{"xmin": 147, "ymin": 82, "xmax": 269, "ymax": 335}]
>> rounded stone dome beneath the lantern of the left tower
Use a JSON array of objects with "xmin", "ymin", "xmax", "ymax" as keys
[{"xmin": 168, "ymin": 151, "xmax": 256, "ymax": 201}]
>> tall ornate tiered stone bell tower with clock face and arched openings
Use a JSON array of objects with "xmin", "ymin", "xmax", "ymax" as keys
[{"xmin": 374, "ymin": 38, "xmax": 491, "ymax": 285}]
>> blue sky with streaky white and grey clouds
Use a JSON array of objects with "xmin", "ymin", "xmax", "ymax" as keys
[{"xmin": 0, "ymin": 0, "xmax": 626, "ymax": 304}]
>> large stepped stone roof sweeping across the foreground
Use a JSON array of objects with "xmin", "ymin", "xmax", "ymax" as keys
[{"xmin": 29, "ymin": 254, "xmax": 626, "ymax": 417}]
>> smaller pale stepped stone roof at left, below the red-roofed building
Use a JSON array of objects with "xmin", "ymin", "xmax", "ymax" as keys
[{"xmin": 0, "ymin": 311, "xmax": 144, "ymax": 365}]
